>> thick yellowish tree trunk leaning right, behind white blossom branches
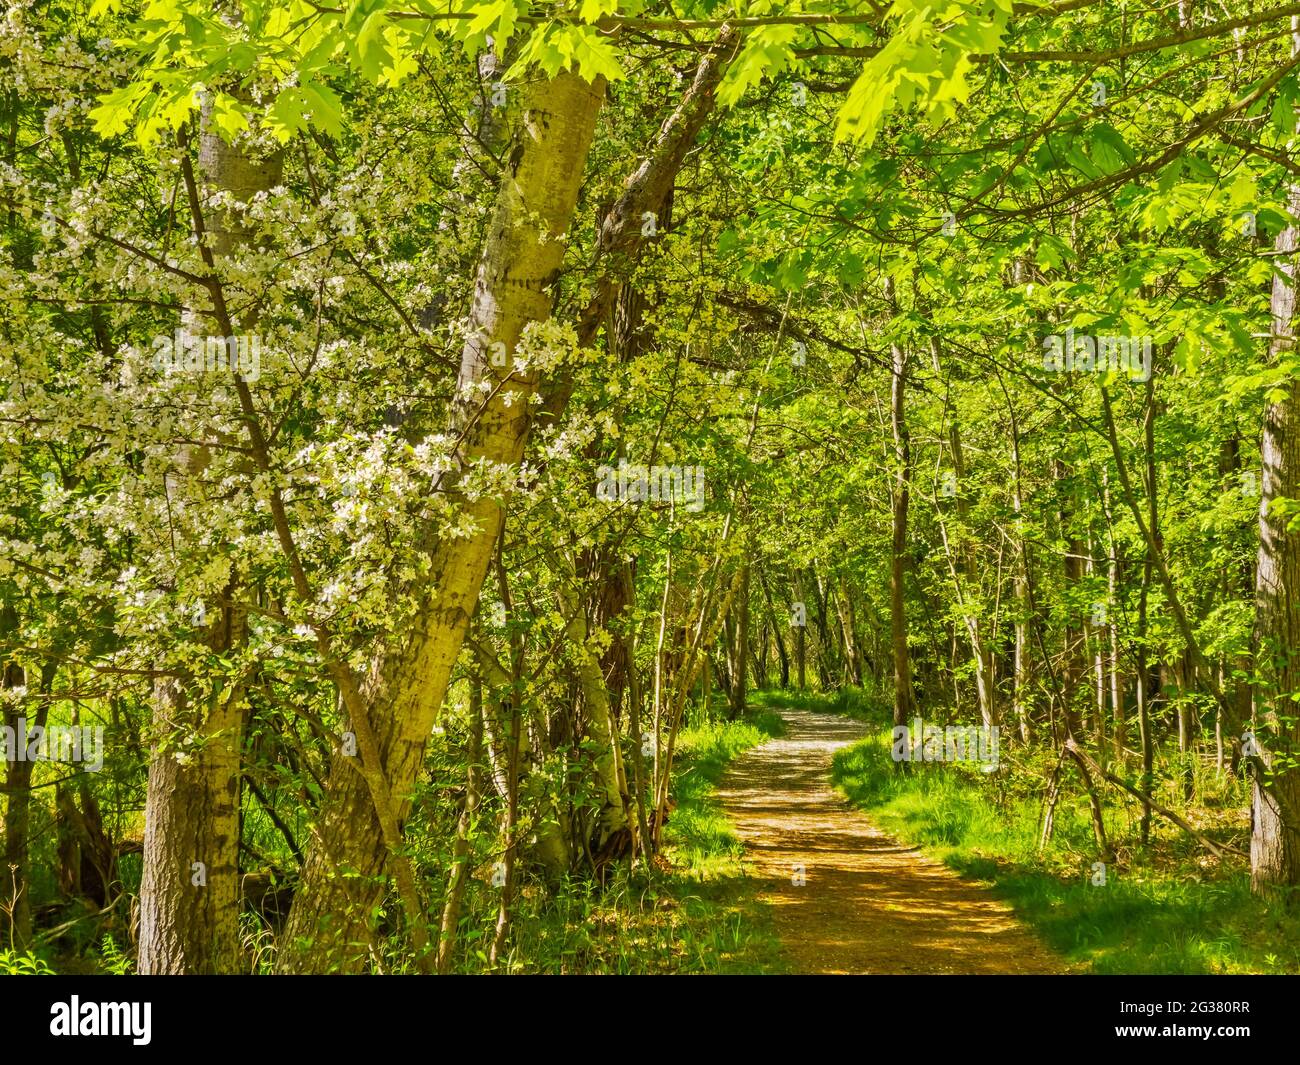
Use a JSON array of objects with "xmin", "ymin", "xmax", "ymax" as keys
[{"xmin": 278, "ymin": 74, "xmax": 605, "ymax": 973}]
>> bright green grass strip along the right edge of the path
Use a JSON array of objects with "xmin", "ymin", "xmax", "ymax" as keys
[{"xmin": 832, "ymin": 731, "xmax": 1300, "ymax": 974}]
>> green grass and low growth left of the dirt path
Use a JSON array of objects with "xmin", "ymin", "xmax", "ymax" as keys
[{"xmin": 35, "ymin": 701, "xmax": 783, "ymax": 975}]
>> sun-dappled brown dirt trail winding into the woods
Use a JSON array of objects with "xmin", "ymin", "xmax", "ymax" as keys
[{"xmin": 719, "ymin": 710, "xmax": 1065, "ymax": 974}]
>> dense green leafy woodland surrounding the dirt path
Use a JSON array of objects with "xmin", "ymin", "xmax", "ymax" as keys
[{"xmin": 0, "ymin": 0, "xmax": 1300, "ymax": 973}]
